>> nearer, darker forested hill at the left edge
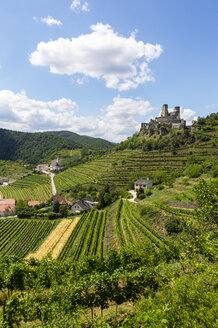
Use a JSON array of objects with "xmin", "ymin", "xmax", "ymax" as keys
[{"xmin": 0, "ymin": 129, "xmax": 79, "ymax": 164}]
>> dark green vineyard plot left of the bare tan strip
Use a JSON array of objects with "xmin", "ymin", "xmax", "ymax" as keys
[{"xmin": 0, "ymin": 219, "xmax": 57, "ymax": 257}]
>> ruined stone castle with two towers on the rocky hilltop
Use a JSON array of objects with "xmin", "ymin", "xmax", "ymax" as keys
[{"xmin": 140, "ymin": 104, "xmax": 186, "ymax": 137}]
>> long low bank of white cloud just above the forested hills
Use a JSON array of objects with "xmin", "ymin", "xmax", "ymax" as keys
[{"xmin": 0, "ymin": 90, "xmax": 154, "ymax": 142}]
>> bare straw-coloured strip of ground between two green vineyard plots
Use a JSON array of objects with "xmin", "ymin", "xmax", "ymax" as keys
[{"xmin": 26, "ymin": 217, "xmax": 80, "ymax": 260}]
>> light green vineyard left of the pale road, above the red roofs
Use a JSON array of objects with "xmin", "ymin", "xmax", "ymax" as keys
[{"xmin": 0, "ymin": 174, "xmax": 52, "ymax": 200}]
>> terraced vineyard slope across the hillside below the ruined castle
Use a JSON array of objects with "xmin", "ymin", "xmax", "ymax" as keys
[{"xmin": 55, "ymin": 138, "xmax": 218, "ymax": 192}]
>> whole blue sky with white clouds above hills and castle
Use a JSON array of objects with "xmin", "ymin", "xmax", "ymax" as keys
[{"xmin": 0, "ymin": 0, "xmax": 218, "ymax": 142}]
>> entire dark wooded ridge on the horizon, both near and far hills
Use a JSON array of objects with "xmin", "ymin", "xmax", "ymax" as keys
[{"xmin": 0, "ymin": 128, "xmax": 114, "ymax": 164}]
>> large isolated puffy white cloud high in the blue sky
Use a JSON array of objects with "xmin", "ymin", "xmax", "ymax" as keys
[{"xmin": 29, "ymin": 22, "xmax": 163, "ymax": 91}]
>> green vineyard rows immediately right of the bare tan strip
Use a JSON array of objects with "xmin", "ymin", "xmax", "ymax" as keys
[{"xmin": 59, "ymin": 210, "xmax": 107, "ymax": 260}]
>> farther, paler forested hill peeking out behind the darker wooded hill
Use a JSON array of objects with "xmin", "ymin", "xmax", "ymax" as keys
[{"xmin": 48, "ymin": 131, "xmax": 115, "ymax": 149}]
